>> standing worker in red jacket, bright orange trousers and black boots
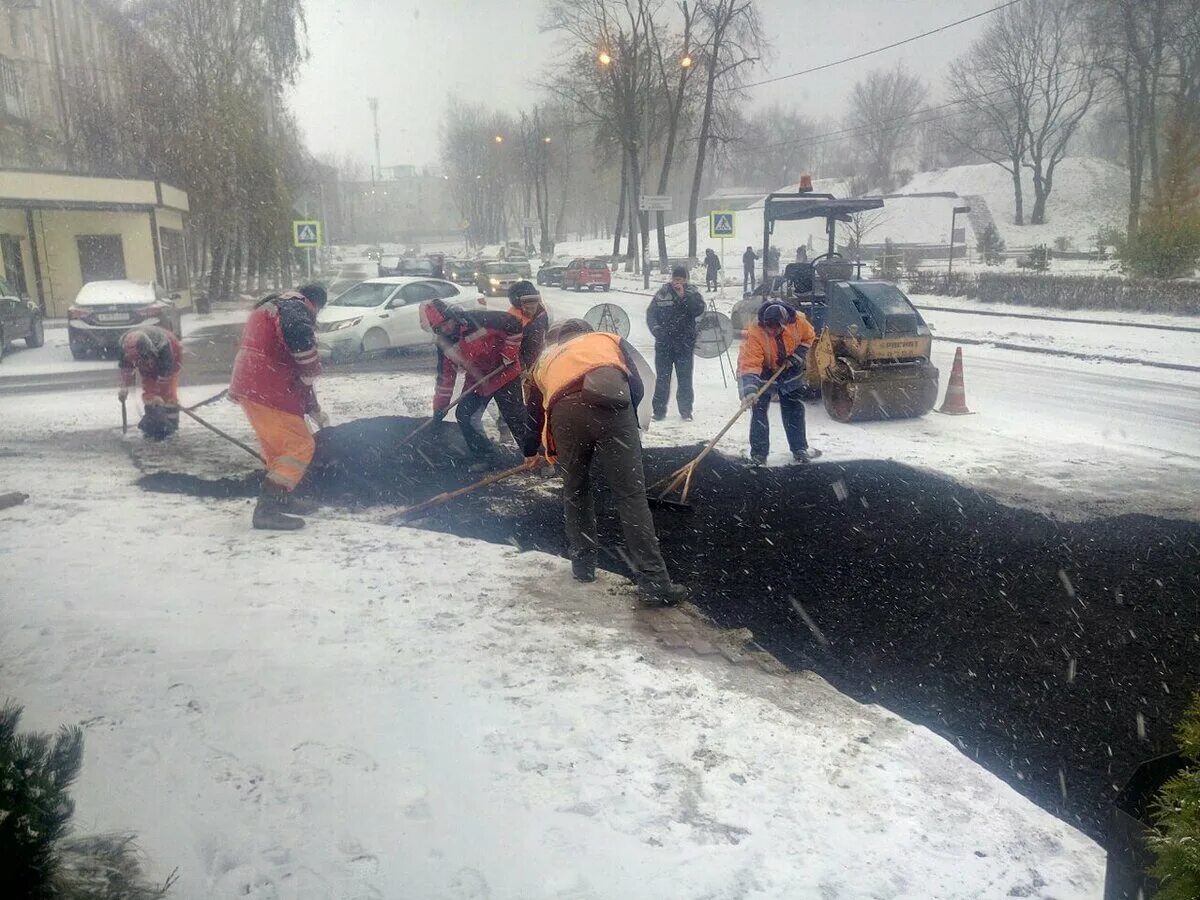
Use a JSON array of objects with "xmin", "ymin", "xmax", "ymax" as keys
[{"xmin": 229, "ymin": 284, "xmax": 329, "ymax": 532}]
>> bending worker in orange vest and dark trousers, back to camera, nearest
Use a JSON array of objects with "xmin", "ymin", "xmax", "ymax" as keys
[{"xmin": 523, "ymin": 319, "xmax": 686, "ymax": 606}]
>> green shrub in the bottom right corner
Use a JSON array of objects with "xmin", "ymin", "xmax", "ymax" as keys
[{"xmin": 1150, "ymin": 694, "xmax": 1200, "ymax": 900}]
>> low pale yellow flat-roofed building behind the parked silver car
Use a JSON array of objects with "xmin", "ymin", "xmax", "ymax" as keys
[{"xmin": 0, "ymin": 169, "xmax": 192, "ymax": 318}]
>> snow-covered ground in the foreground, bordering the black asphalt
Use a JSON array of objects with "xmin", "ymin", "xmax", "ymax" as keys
[{"xmin": 0, "ymin": 384, "xmax": 1103, "ymax": 900}]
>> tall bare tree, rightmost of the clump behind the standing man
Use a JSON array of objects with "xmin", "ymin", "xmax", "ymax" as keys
[{"xmin": 688, "ymin": 0, "xmax": 767, "ymax": 259}]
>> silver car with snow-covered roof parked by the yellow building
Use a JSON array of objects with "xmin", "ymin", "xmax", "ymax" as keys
[{"xmin": 67, "ymin": 281, "xmax": 184, "ymax": 359}]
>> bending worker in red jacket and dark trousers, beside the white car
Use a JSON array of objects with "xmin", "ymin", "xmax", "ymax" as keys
[{"xmin": 421, "ymin": 300, "xmax": 526, "ymax": 472}]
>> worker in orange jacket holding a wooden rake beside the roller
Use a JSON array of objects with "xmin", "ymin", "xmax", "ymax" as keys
[{"xmin": 738, "ymin": 300, "xmax": 820, "ymax": 466}]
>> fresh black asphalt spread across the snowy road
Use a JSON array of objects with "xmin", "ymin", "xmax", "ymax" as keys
[{"xmin": 142, "ymin": 419, "xmax": 1200, "ymax": 836}]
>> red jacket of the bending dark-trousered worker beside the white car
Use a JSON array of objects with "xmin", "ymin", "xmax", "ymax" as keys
[{"xmin": 433, "ymin": 312, "xmax": 524, "ymax": 412}]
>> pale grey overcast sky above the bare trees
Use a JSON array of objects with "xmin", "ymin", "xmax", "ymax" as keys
[{"xmin": 292, "ymin": 0, "xmax": 1000, "ymax": 166}]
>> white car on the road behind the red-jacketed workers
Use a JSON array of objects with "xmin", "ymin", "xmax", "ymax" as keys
[{"xmin": 317, "ymin": 276, "xmax": 486, "ymax": 362}]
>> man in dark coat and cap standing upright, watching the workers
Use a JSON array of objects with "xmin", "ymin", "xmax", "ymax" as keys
[{"xmin": 646, "ymin": 265, "xmax": 704, "ymax": 421}]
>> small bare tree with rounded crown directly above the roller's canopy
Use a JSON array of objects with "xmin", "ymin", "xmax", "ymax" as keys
[{"xmin": 850, "ymin": 62, "xmax": 928, "ymax": 188}]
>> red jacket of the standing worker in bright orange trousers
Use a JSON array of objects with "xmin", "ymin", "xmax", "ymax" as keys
[{"xmin": 229, "ymin": 290, "xmax": 320, "ymax": 415}]
